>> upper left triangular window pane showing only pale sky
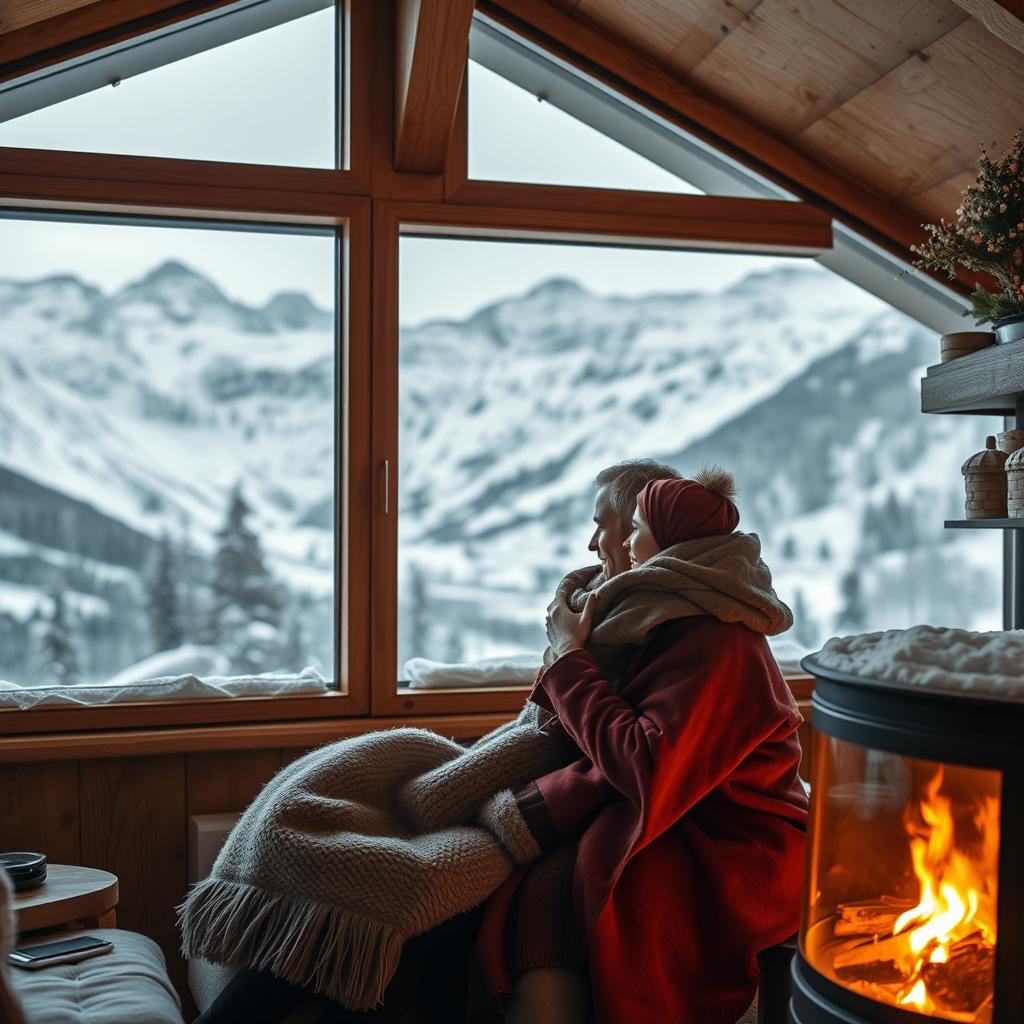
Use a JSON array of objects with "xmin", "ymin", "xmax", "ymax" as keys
[{"xmin": 0, "ymin": 7, "xmax": 339, "ymax": 167}]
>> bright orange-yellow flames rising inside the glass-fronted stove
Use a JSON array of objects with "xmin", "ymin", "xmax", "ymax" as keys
[{"xmin": 892, "ymin": 768, "xmax": 999, "ymax": 1013}]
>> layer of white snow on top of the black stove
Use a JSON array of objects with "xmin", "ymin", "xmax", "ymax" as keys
[{"xmin": 811, "ymin": 626, "xmax": 1024, "ymax": 702}]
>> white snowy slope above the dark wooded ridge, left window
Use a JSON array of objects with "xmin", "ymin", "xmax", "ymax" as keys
[{"xmin": 0, "ymin": 262, "xmax": 335, "ymax": 581}]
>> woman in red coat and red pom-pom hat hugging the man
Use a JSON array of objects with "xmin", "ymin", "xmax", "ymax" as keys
[{"xmin": 478, "ymin": 472, "xmax": 807, "ymax": 1024}]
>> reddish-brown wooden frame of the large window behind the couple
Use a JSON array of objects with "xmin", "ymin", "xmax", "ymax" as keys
[{"xmin": 371, "ymin": 199, "xmax": 831, "ymax": 716}]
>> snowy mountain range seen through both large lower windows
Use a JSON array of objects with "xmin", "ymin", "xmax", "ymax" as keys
[{"xmin": 0, "ymin": 262, "xmax": 998, "ymax": 676}]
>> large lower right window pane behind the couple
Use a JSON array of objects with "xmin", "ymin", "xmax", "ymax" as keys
[{"xmin": 398, "ymin": 238, "xmax": 1001, "ymax": 678}]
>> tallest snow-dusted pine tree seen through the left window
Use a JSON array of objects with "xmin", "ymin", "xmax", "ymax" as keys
[{"xmin": 207, "ymin": 486, "xmax": 284, "ymax": 673}]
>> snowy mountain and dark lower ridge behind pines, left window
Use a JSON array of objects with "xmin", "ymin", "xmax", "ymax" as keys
[{"xmin": 0, "ymin": 262, "xmax": 336, "ymax": 678}]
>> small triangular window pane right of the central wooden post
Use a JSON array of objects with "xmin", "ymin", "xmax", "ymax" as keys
[{"xmin": 468, "ymin": 60, "xmax": 700, "ymax": 194}]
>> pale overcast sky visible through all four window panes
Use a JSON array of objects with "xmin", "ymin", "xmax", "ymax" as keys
[{"xmin": 0, "ymin": 10, "xmax": 798, "ymax": 324}]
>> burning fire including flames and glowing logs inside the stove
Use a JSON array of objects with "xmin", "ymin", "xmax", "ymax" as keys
[{"xmin": 831, "ymin": 767, "xmax": 999, "ymax": 1024}]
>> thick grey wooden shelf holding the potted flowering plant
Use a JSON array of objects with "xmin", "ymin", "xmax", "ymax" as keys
[{"xmin": 921, "ymin": 341, "xmax": 1024, "ymax": 416}]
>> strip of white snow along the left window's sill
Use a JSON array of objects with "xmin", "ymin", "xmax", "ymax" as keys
[{"xmin": 0, "ymin": 668, "xmax": 331, "ymax": 711}]
